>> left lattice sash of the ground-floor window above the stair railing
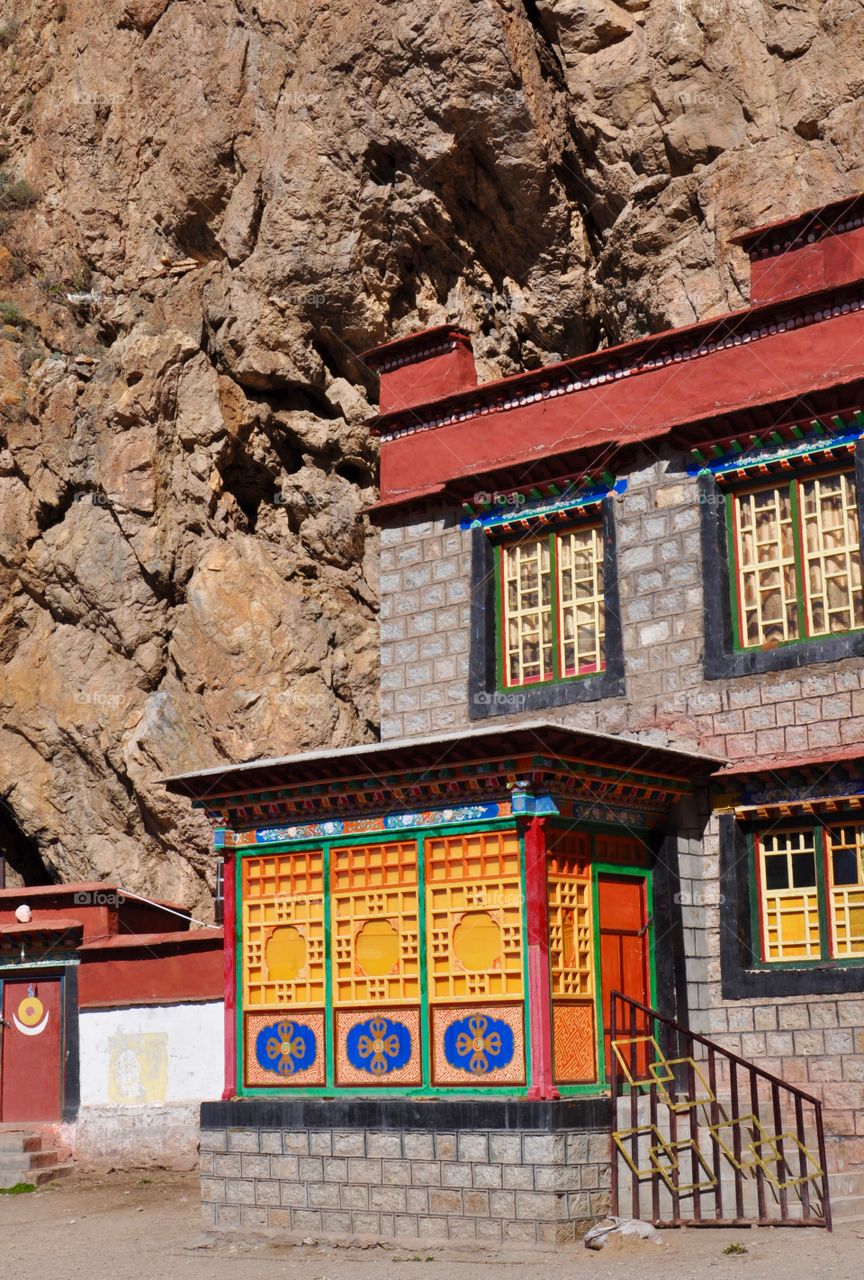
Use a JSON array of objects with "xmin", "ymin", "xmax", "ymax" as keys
[{"xmin": 758, "ymin": 831, "xmax": 820, "ymax": 960}]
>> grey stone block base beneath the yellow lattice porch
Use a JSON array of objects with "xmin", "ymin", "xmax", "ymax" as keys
[{"xmin": 201, "ymin": 1126, "xmax": 609, "ymax": 1245}]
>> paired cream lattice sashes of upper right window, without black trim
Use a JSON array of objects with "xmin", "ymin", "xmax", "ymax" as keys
[{"xmin": 728, "ymin": 471, "xmax": 864, "ymax": 649}]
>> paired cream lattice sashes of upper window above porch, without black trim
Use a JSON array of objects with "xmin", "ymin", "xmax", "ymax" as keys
[{"xmin": 498, "ymin": 525, "xmax": 605, "ymax": 687}]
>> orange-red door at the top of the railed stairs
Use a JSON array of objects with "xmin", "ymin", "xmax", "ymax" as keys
[{"xmin": 598, "ymin": 876, "xmax": 650, "ymax": 1078}]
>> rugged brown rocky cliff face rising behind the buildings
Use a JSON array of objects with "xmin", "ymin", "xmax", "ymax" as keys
[{"xmin": 0, "ymin": 0, "xmax": 864, "ymax": 911}]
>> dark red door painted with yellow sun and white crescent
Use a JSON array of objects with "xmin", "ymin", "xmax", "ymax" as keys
[{"xmin": 0, "ymin": 977, "xmax": 63, "ymax": 1124}]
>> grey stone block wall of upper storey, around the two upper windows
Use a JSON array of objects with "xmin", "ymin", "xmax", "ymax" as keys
[{"xmin": 380, "ymin": 451, "xmax": 864, "ymax": 760}]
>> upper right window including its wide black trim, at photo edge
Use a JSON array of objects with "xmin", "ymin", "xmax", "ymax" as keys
[{"xmin": 699, "ymin": 438, "xmax": 864, "ymax": 680}]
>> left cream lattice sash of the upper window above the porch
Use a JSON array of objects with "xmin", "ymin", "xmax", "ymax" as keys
[{"xmin": 502, "ymin": 536, "xmax": 553, "ymax": 685}]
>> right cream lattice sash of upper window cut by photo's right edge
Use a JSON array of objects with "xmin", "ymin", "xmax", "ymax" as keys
[{"xmin": 799, "ymin": 472, "xmax": 864, "ymax": 635}]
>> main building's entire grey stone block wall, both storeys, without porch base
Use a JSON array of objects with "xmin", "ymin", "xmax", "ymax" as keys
[{"xmin": 381, "ymin": 445, "xmax": 864, "ymax": 1164}]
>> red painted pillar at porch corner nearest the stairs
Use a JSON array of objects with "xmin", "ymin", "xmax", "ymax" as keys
[{"xmin": 525, "ymin": 817, "xmax": 561, "ymax": 1098}]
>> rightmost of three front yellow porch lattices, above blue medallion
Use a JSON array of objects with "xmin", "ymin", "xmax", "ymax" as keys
[{"xmin": 426, "ymin": 832, "xmax": 522, "ymax": 1001}]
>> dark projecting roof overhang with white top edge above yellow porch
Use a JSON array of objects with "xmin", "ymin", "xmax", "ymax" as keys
[{"xmin": 164, "ymin": 721, "xmax": 724, "ymax": 828}]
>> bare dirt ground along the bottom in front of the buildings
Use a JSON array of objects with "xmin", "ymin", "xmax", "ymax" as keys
[{"xmin": 0, "ymin": 1172, "xmax": 864, "ymax": 1280}]
